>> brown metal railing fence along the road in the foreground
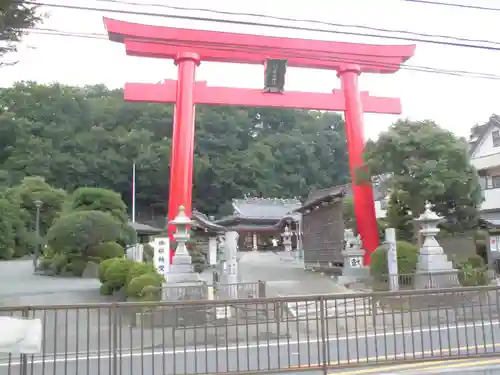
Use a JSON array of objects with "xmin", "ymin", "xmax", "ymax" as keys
[{"xmin": 0, "ymin": 286, "xmax": 500, "ymax": 375}]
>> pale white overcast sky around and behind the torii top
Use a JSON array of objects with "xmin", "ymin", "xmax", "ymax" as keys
[{"xmin": 0, "ymin": 0, "xmax": 500, "ymax": 139}]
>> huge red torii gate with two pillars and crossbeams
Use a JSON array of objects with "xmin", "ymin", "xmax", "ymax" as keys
[{"xmin": 104, "ymin": 18, "xmax": 415, "ymax": 264}]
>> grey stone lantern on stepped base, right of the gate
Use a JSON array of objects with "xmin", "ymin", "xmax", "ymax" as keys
[{"xmin": 414, "ymin": 203, "xmax": 459, "ymax": 289}]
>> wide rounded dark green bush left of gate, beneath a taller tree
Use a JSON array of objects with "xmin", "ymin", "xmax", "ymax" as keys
[{"xmin": 47, "ymin": 211, "xmax": 122, "ymax": 256}]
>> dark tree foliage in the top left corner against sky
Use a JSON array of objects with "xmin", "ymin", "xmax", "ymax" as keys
[{"xmin": 0, "ymin": 0, "xmax": 42, "ymax": 66}]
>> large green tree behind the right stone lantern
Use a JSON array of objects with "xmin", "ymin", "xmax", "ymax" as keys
[{"xmin": 365, "ymin": 120, "xmax": 482, "ymax": 239}]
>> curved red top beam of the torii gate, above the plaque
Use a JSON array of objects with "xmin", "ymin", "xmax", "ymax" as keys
[{"xmin": 104, "ymin": 18, "xmax": 415, "ymax": 73}]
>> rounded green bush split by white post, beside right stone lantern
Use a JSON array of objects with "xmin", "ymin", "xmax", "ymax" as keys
[{"xmin": 370, "ymin": 241, "xmax": 418, "ymax": 277}]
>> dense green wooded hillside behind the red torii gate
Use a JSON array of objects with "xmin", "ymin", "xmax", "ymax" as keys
[{"xmin": 0, "ymin": 82, "xmax": 348, "ymax": 221}]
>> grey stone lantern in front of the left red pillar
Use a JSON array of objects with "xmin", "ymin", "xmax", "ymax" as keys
[{"xmin": 163, "ymin": 206, "xmax": 200, "ymax": 300}]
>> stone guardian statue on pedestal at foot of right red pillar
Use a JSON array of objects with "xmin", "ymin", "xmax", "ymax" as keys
[{"xmin": 338, "ymin": 229, "xmax": 369, "ymax": 285}]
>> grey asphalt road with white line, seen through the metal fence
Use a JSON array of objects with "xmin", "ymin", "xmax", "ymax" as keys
[{"xmin": 0, "ymin": 322, "xmax": 500, "ymax": 375}]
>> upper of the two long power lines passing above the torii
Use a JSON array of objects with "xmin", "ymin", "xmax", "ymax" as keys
[{"xmin": 89, "ymin": 0, "xmax": 500, "ymax": 45}]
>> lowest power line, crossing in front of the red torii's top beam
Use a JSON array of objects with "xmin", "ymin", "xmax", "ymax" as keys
[{"xmin": 26, "ymin": 28, "xmax": 500, "ymax": 80}]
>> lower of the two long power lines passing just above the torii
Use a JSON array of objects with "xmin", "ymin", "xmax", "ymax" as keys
[{"xmin": 23, "ymin": 1, "xmax": 500, "ymax": 51}]
